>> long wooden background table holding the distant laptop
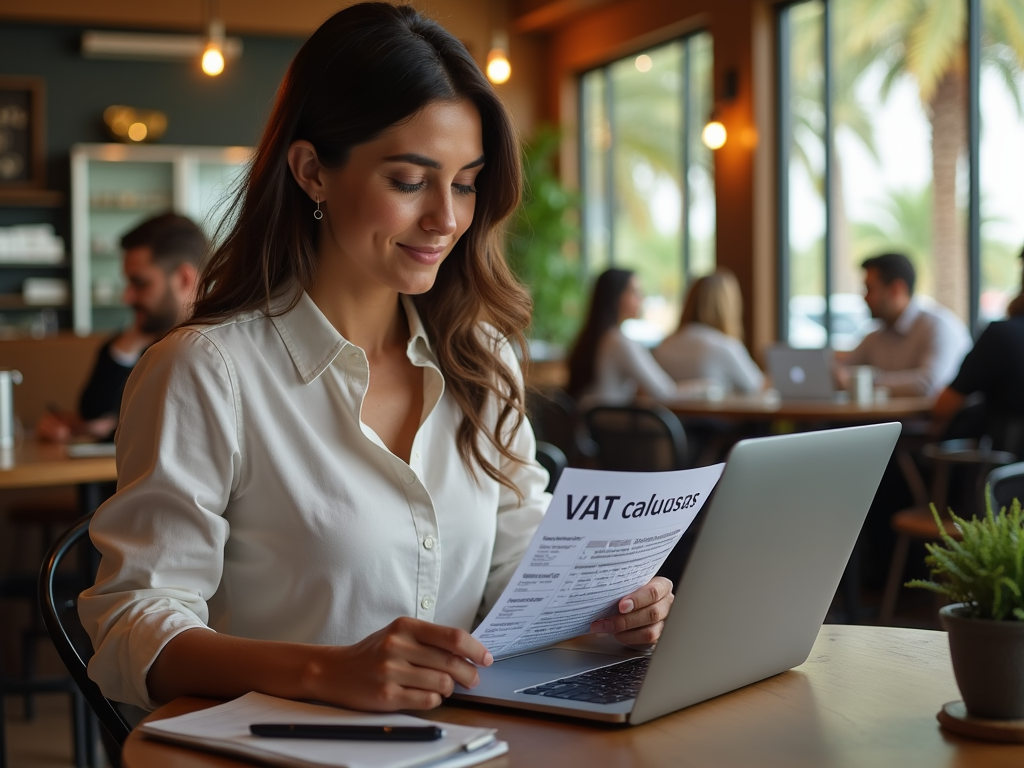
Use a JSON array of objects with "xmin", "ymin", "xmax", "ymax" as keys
[{"xmin": 662, "ymin": 395, "xmax": 932, "ymax": 424}]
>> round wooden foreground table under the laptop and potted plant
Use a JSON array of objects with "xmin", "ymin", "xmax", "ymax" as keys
[{"xmin": 122, "ymin": 625, "xmax": 1024, "ymax": 768}]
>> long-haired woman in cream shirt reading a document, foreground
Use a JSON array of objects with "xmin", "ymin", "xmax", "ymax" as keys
[{"xmin": 80, "ymin": 3, "xmax": 671, "ymax": 711}]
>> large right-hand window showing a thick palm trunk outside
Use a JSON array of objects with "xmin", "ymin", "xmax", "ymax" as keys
[{"xmin": 778, "ymin": 0, "xmax": 1024, "ymax": 349}]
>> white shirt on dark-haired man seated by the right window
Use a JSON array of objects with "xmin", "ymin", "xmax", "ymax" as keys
[{"xmin": 844, "ymin": 298, "xmax": 972, "ymax": 397}]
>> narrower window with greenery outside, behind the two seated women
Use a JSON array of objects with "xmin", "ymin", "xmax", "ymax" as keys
[{"xmin": 580, "ymin": 33, "xmax": 715, "ymax": 343}]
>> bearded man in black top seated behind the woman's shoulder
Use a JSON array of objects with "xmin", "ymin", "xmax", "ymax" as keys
[{"xmin": 36, "ymin": 213, "xmax": 208, "ymax": 442}]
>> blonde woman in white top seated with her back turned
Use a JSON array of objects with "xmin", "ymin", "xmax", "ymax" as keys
[{"xmin": 654, "ymin": 268, "xmax": 764, "ymax": 394}]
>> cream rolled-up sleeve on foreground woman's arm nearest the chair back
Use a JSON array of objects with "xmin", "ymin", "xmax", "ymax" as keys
[{"xmin": 79, "ymin": 330, "xmax": 243, "ymax": 709}]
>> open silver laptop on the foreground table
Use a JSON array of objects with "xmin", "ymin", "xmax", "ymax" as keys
[{"xmin": 454, "ymin": 423, "xmax": 900, "ymax": 724}]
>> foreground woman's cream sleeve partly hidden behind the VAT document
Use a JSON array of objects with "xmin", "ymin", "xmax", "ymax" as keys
[{"xmin": 480, "ymin": 344, "xmax": 551, "ymax": 617}]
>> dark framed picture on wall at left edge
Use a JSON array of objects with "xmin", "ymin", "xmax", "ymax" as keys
[{"xmin": 0, "ymin": 75, "xmax": 46, "ymax": 190}]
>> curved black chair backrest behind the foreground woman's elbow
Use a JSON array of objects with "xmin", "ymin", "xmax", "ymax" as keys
[{"xmin": 39, "ymin": 514, "xmax": 131, "ymax": 745}]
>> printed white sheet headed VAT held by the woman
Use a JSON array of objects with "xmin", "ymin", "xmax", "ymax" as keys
[{"xmin": 473, "ymin": 464, "xmax": 725, "ymax": 658}]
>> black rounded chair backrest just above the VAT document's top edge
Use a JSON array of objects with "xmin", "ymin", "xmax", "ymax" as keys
[{"xmin": 584, "ymin": 406, "xmax": 687, "ymax": 472}]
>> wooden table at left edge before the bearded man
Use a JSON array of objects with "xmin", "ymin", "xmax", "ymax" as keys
[{"xmin": 0, "ymin": 440, "xmax": 118, "ymax": 489}]
